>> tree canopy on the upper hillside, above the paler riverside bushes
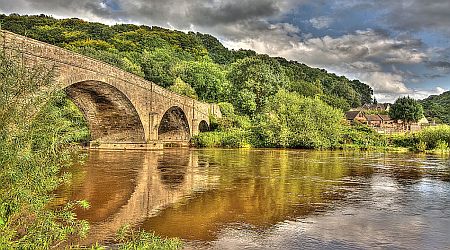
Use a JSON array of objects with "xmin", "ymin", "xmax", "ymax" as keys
[{"xmin": 0, "ymin": 14, "xmax": 373, "ymax": 116}]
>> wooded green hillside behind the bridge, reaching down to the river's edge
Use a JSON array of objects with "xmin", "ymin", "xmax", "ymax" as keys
[{"xmin": 0, "ymin": 14, "xmax": 373, "ymax": 148}]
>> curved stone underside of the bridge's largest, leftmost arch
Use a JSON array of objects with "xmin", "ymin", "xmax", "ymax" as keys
[{"xmin": 65, "ymin": 81, "xmax": 145, "ymax": 143}]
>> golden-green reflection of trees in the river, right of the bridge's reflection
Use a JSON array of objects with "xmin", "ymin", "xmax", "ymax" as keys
[{"xmin": 144, "ymin": 150, "xmax": 373, "ymax": 239}]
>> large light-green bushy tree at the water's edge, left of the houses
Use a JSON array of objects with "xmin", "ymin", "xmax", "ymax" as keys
[{"xmin": 255, "ymin": 90, "xmax": 343, "ymax": 148}]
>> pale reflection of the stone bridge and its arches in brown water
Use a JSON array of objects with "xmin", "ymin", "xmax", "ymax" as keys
[{"xmin": 61, "ymin": 148, "xmax": 217, "ymax": 244}]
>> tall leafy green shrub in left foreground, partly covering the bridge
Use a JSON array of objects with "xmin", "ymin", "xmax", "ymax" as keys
[{"xmin": 0, "ymin": 51, "xmax": 89, "ymax": 249}]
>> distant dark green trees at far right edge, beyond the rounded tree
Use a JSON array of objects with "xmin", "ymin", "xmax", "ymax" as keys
[{"xmin": 421, "ymin": 91, "xmax": 450, "ymax": 124}]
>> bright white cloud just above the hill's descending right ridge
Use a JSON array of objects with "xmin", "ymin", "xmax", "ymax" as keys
[{"xmin": 225, "ymin": 26, "xmax": 427, "ymax": 100}]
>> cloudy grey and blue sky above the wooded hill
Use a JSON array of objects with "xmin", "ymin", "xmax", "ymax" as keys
[{"xmin": 0, "ymin": 0, "xmax": 450, "ymax": 102}]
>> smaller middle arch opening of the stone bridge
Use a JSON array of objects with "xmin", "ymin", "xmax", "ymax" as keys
[{"xmin": 158, "ymin": 106, "xmax": 191, "ymax": 141}]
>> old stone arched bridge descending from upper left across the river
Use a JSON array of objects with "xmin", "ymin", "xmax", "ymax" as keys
[{"xmin": 0, "ymin": 30, "xmax": 221, "ymax": 149}]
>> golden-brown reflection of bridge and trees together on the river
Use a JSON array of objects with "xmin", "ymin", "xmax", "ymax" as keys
[{"xmin": 60, "ymin": 149, "xmax": 372, "ymax": 243}]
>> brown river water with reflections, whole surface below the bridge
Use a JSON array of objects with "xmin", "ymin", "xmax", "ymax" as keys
[{"xmin": 59, "ymin": 149, "xmax": 450, "ymax": 249}]
